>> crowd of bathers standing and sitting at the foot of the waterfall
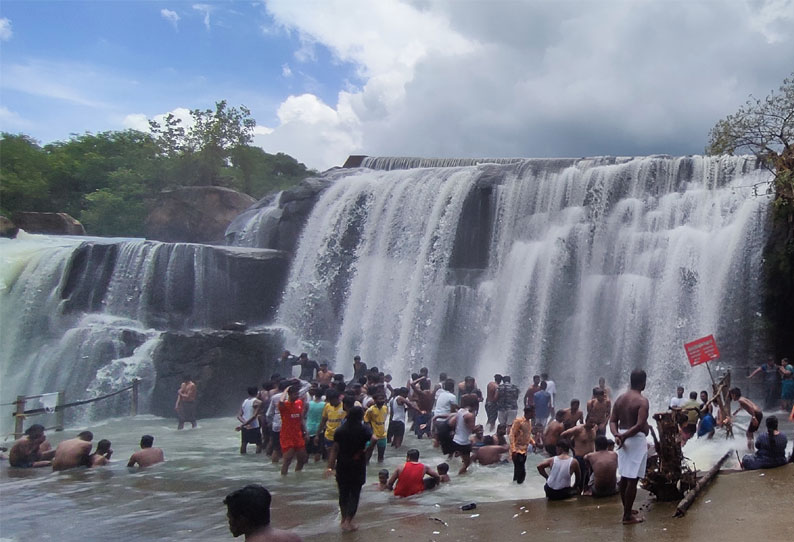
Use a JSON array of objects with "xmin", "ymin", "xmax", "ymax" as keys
[{"xmin": 3, "ymin": 351, "xmax": 794, "ymax": 540}]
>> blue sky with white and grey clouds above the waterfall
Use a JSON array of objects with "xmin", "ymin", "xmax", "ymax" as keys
[{"xmin": 0, "ymin": 0, "xmax": 794, "ymax": 170}]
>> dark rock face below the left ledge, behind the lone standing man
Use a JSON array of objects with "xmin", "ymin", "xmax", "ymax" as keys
[{"xmin": 150, "ymin": 330, "xmax": 284, "ymax": 418}]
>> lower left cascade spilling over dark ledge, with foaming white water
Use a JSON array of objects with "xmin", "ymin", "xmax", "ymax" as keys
[{"xmin": 0, "ymin": 232, "xmax": 284, "ymax": 430}]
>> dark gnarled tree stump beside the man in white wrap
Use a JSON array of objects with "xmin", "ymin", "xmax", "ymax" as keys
[{"xmin": 642, "ymin": 412, "xmax": 696, "ymax": 501}]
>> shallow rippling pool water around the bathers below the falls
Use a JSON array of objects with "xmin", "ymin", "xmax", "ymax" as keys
[{"xmin": 0, "ymin": 416, "xmax": 772, "ymax": 541}]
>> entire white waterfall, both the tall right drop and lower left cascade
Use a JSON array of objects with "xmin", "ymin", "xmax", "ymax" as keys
[{"xmin": 0, "ymin": 156, "xmax": 770, "ymax": 429}]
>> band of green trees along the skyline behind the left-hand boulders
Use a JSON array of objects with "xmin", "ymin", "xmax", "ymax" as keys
[{"xmin": 0, "ymin": 101, "xmax": 313, "ymax": 236}]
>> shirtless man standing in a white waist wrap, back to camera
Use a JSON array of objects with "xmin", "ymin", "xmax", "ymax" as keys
[{"xmin": 609, "ymin": 369, "xmax": 649, "ymax": 525}]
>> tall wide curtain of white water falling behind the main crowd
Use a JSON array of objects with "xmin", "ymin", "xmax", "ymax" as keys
[{"xmin": 266, "ymin": 157, "xmax": 769, "ymax": 402}]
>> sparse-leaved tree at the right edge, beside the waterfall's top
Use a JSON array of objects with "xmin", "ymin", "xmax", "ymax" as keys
[{"xmin": 706, "ymin": 73, "xmax": 794, "ymax": 206}]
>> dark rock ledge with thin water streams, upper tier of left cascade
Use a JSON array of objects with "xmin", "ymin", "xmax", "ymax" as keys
[{"xmin": 60, "ymin": 241, "xmax": 289, "ymax": 330}]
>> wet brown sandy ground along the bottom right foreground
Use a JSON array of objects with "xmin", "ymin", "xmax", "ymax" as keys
[{"xmin": 312, "ymin": 464, "xmax": 794, "ymax": 542}]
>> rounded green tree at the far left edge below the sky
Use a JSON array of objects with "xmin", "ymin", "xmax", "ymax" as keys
[{"xmin": 0, "ymin": 132, "xmax": 53, "ymax": 215}]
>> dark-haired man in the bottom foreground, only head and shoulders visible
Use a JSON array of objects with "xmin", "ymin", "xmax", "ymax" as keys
[{"xmin": 223, "ymin": 484, "xmax": 301, "ymax": 542}]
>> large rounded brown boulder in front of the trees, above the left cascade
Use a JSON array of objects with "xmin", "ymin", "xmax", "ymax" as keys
[{"xmin": 146, "ymin": 186, "xmax": 256, "ymax": 244}]
